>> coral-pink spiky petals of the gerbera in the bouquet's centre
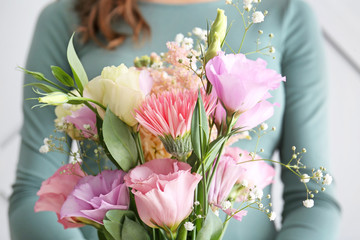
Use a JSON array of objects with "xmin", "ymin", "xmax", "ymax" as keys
[{"xmin": 135, "ymin": 90, "xmax": 215, "ymax": 139}]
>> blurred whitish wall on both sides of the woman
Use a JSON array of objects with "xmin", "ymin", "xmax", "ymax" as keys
[{"xmin": 0, "ymin": 0, "xmax": 360, "ymax": 240}]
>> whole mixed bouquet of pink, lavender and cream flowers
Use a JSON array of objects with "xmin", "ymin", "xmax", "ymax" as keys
[{"xmin": 24, "ymin": 1, "xmax": 332, "ymax": 240}]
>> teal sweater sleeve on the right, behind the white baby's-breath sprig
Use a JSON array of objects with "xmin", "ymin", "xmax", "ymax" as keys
[{"xmin": 276, "ymin": 0, "xmax": 340, "ymax": 240}]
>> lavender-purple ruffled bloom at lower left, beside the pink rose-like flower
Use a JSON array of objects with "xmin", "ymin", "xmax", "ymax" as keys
[{"xmin": 60, "ymin": 170, "xmax": 130, "ymax": 225}]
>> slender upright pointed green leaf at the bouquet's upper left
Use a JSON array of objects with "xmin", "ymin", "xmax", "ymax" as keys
[{"xmin": 67, "ymin": 33, "xmax": 89, "ymax": 94}]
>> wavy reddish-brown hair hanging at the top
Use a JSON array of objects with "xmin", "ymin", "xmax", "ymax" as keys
[{"xmin": 75, "ymin": 0, "xmax": 150, "ymax": 49}]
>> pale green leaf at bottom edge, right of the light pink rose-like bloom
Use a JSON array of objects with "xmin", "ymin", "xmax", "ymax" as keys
[{"xmin": 196, "ymin": 209, "xmax": 222, "ymax": 240}]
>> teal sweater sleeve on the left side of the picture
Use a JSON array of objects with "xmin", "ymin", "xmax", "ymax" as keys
[{"xmin": 9, "ymin": 1, "xmax": 96, "ymax": 240}]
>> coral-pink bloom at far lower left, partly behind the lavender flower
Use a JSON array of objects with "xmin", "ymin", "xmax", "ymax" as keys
[{"xmin": 34, "ymin": 163, "xmax": 85, "ymax": 229}]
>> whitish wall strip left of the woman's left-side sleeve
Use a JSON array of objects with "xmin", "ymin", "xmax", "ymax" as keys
[{"xmin": 0, "ymin": 0, "xmax": 50, "ymax": 240}]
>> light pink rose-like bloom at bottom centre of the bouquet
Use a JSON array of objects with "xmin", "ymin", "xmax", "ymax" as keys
[{"xmin": 125, "ymin": 158, "xmax": 201, "ymax": 232}]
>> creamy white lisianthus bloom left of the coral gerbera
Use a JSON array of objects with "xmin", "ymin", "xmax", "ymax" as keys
[{"xmin": 84, "ymin": 64, "xmax": 153, "ymax": 126}]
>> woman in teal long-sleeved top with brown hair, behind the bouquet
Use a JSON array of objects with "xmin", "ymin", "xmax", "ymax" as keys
[{"xmin": 9, "ymin": 0, "xmax": 339, "ymax": 240}]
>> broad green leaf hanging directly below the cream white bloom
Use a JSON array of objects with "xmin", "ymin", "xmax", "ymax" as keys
[{"xmin": 103, "ymin": 108, "xmax": 138, "ymax": 172}]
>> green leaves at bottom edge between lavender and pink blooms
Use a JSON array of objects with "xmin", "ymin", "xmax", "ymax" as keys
[{"xmin": 103, "ymin": 210, "xmax": 150, "ymax": 240}]
